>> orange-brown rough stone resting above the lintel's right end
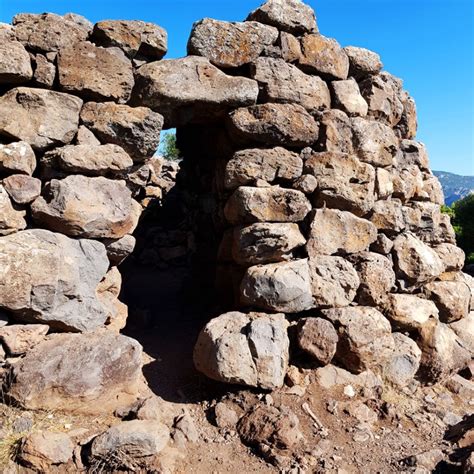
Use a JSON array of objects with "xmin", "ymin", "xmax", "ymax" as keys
[{"xmin": 188, "ymin": 18, "xmax": 278, "ymax": 68}]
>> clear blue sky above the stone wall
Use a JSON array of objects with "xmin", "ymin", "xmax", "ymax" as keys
[{"xmin": 0, "ymin": 0, "xmax": 474, "ymax": 175}]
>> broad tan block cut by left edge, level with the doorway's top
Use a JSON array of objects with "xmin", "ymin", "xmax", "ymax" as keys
[{"xmin": 0, "ymin": 87, "xmax": 82, "ymax": 151}]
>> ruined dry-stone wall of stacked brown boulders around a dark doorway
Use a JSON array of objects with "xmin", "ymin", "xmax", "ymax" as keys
[{"xmin": 0, "ymin": 0, "xmax": 474, "ymax": 468}]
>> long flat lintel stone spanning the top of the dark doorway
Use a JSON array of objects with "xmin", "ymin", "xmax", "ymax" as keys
[{"xmin": 134, "ymin": 56, "xmax": 258, "ymax": 128}]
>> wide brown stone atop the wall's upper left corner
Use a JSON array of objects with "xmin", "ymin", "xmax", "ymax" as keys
[{"xmin": 13, "ymin": 13, "xmax": 92, "ymax": 53}]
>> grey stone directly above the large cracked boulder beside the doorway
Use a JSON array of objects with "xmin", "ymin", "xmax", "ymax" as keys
[{"xmin": 240, "ymin": 259, "xmax": 314, "ymax": 313}]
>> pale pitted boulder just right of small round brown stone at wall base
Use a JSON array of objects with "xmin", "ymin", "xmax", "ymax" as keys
[{"xmin": 323, "ymin": 306, "xmax": 394, "ymax": 373}]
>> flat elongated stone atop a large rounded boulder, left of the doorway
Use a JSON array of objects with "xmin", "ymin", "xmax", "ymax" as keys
[{"xmin": 41, "ymin": 144, "xmax": 133, "ymax": 176}]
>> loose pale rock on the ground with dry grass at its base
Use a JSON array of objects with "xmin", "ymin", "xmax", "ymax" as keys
[{"xmin": 90, "ymin": 420, "xmax": 170, "ymax": 471}]
